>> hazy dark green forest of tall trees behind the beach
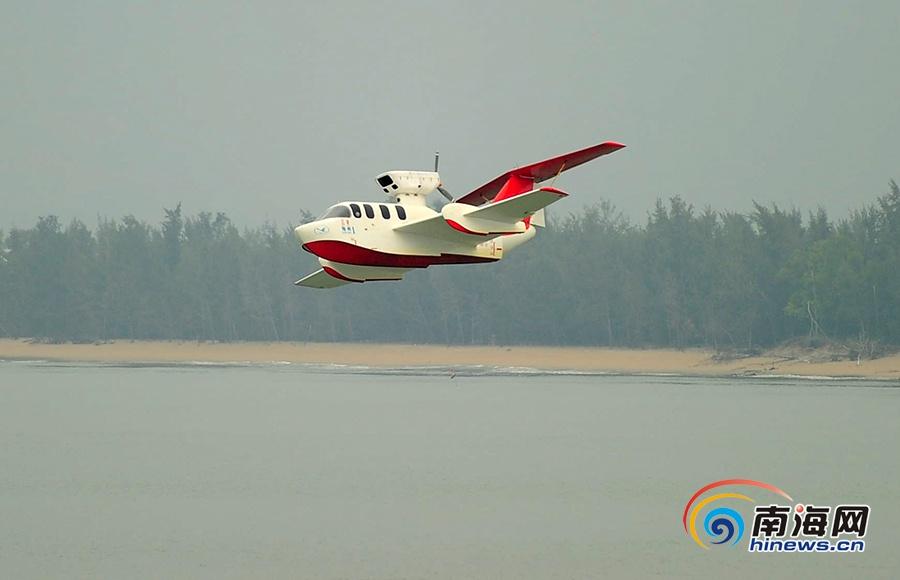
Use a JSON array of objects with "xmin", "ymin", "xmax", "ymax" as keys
[{"xmin": 0, "ymin": 181, "xmax": 900, "ymax": 351}]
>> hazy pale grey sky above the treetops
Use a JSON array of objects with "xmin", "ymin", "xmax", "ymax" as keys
[{"xmin": 0, "ymin": 0, "xmax": 900, "ymax": 228}]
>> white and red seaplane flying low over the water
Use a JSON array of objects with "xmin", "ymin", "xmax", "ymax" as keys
[{"xmin": 294, "ymin": 141, "xmax": 625, "ymax": 288}]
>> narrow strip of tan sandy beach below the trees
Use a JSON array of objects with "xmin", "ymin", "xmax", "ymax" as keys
[{"xmin": 0, "ymin": 339, "xmax": 900, "ymax": 380}]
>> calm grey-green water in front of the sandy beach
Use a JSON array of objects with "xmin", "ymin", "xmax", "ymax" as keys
[{"xmin": 0, "ymin": 362, "xmax": 900, "ymax": 579}]
